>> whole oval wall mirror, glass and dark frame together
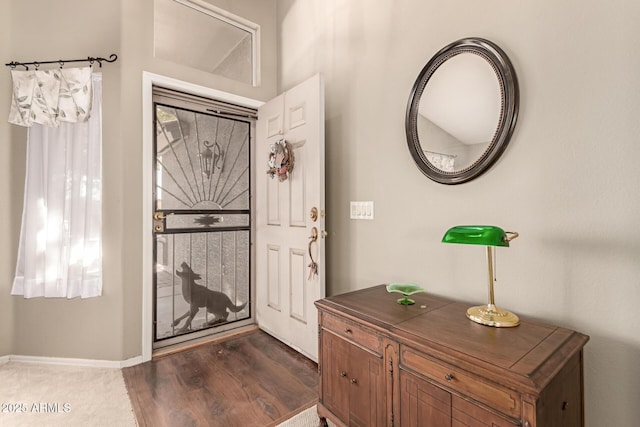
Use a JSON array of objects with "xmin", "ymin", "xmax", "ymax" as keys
[{"xmin": 405, "ymin": 37, "xmax": 519, "ymax": 184}]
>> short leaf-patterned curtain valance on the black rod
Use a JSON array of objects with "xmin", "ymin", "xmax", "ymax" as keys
[{"xmin": 9, "ymin": 67, "xmax": 93, "ymax": 127}]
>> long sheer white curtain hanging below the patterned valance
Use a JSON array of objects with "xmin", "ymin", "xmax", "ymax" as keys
[{"xmin": 11, "ymin": 73, "xmax": 102, "ymax": 298}]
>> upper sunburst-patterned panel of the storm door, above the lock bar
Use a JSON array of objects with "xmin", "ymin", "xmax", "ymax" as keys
[{"xmin": 156, "ymin": 105, "xmax": 250, "ymax": 210}]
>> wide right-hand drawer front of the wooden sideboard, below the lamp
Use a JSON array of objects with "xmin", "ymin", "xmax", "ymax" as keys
[{"xmin": 400, "ymin": 346, "xmax": 521, "ymax": 418}]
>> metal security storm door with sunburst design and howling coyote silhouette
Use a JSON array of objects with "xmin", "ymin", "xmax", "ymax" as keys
[{"xmin": 153, "ymin": 87, "xmax": 255, "ymax": 348}]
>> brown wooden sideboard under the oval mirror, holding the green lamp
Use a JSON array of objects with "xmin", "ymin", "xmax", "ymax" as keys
[{"xmin": 316, "ymin": 285, "xmax": 589, "ymax": 427}]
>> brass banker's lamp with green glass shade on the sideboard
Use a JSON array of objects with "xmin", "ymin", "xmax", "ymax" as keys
[{"xmin": 442, "ymin": 225, "xmax": 520, "ymax": 328}]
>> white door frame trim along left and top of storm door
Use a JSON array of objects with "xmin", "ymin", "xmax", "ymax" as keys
[{"xmin": 141, "ymin": 71, "xmax": 264, "ymax": 362}]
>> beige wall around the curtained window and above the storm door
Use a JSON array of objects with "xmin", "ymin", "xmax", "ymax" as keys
[{"xmin": 0, "ymin": 0, "xmax": 277, "ymax": 361}]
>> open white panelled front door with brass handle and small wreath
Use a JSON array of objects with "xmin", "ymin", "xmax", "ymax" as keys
[{"xmin": 255, "ymin": 75, "xmax": 325, "ymax": 361}]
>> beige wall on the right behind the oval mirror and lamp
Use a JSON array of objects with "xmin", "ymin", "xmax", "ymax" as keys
[{"xmin": 278, "ymin": 0, "xmax": 640, "ymax": 427}]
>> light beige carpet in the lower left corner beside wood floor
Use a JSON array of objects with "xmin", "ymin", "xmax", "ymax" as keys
[{"xmin": 0, "ymin": 362, "xmax": 136, "ymax": 427}]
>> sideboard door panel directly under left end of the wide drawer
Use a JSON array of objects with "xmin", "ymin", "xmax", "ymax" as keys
[{"xmin": 400, "ymin": 370, "xmax": 451, "ymax": 427}]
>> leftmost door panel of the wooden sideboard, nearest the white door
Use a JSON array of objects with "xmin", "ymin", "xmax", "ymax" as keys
[{"xmin": 321, "ymin": 331, "xmax": 351, "ymax": 420}]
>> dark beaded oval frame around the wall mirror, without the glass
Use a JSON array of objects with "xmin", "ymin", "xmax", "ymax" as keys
[{"xmin": 405, "ymin": 37, "xmax": 520, "ymax": 184}]
